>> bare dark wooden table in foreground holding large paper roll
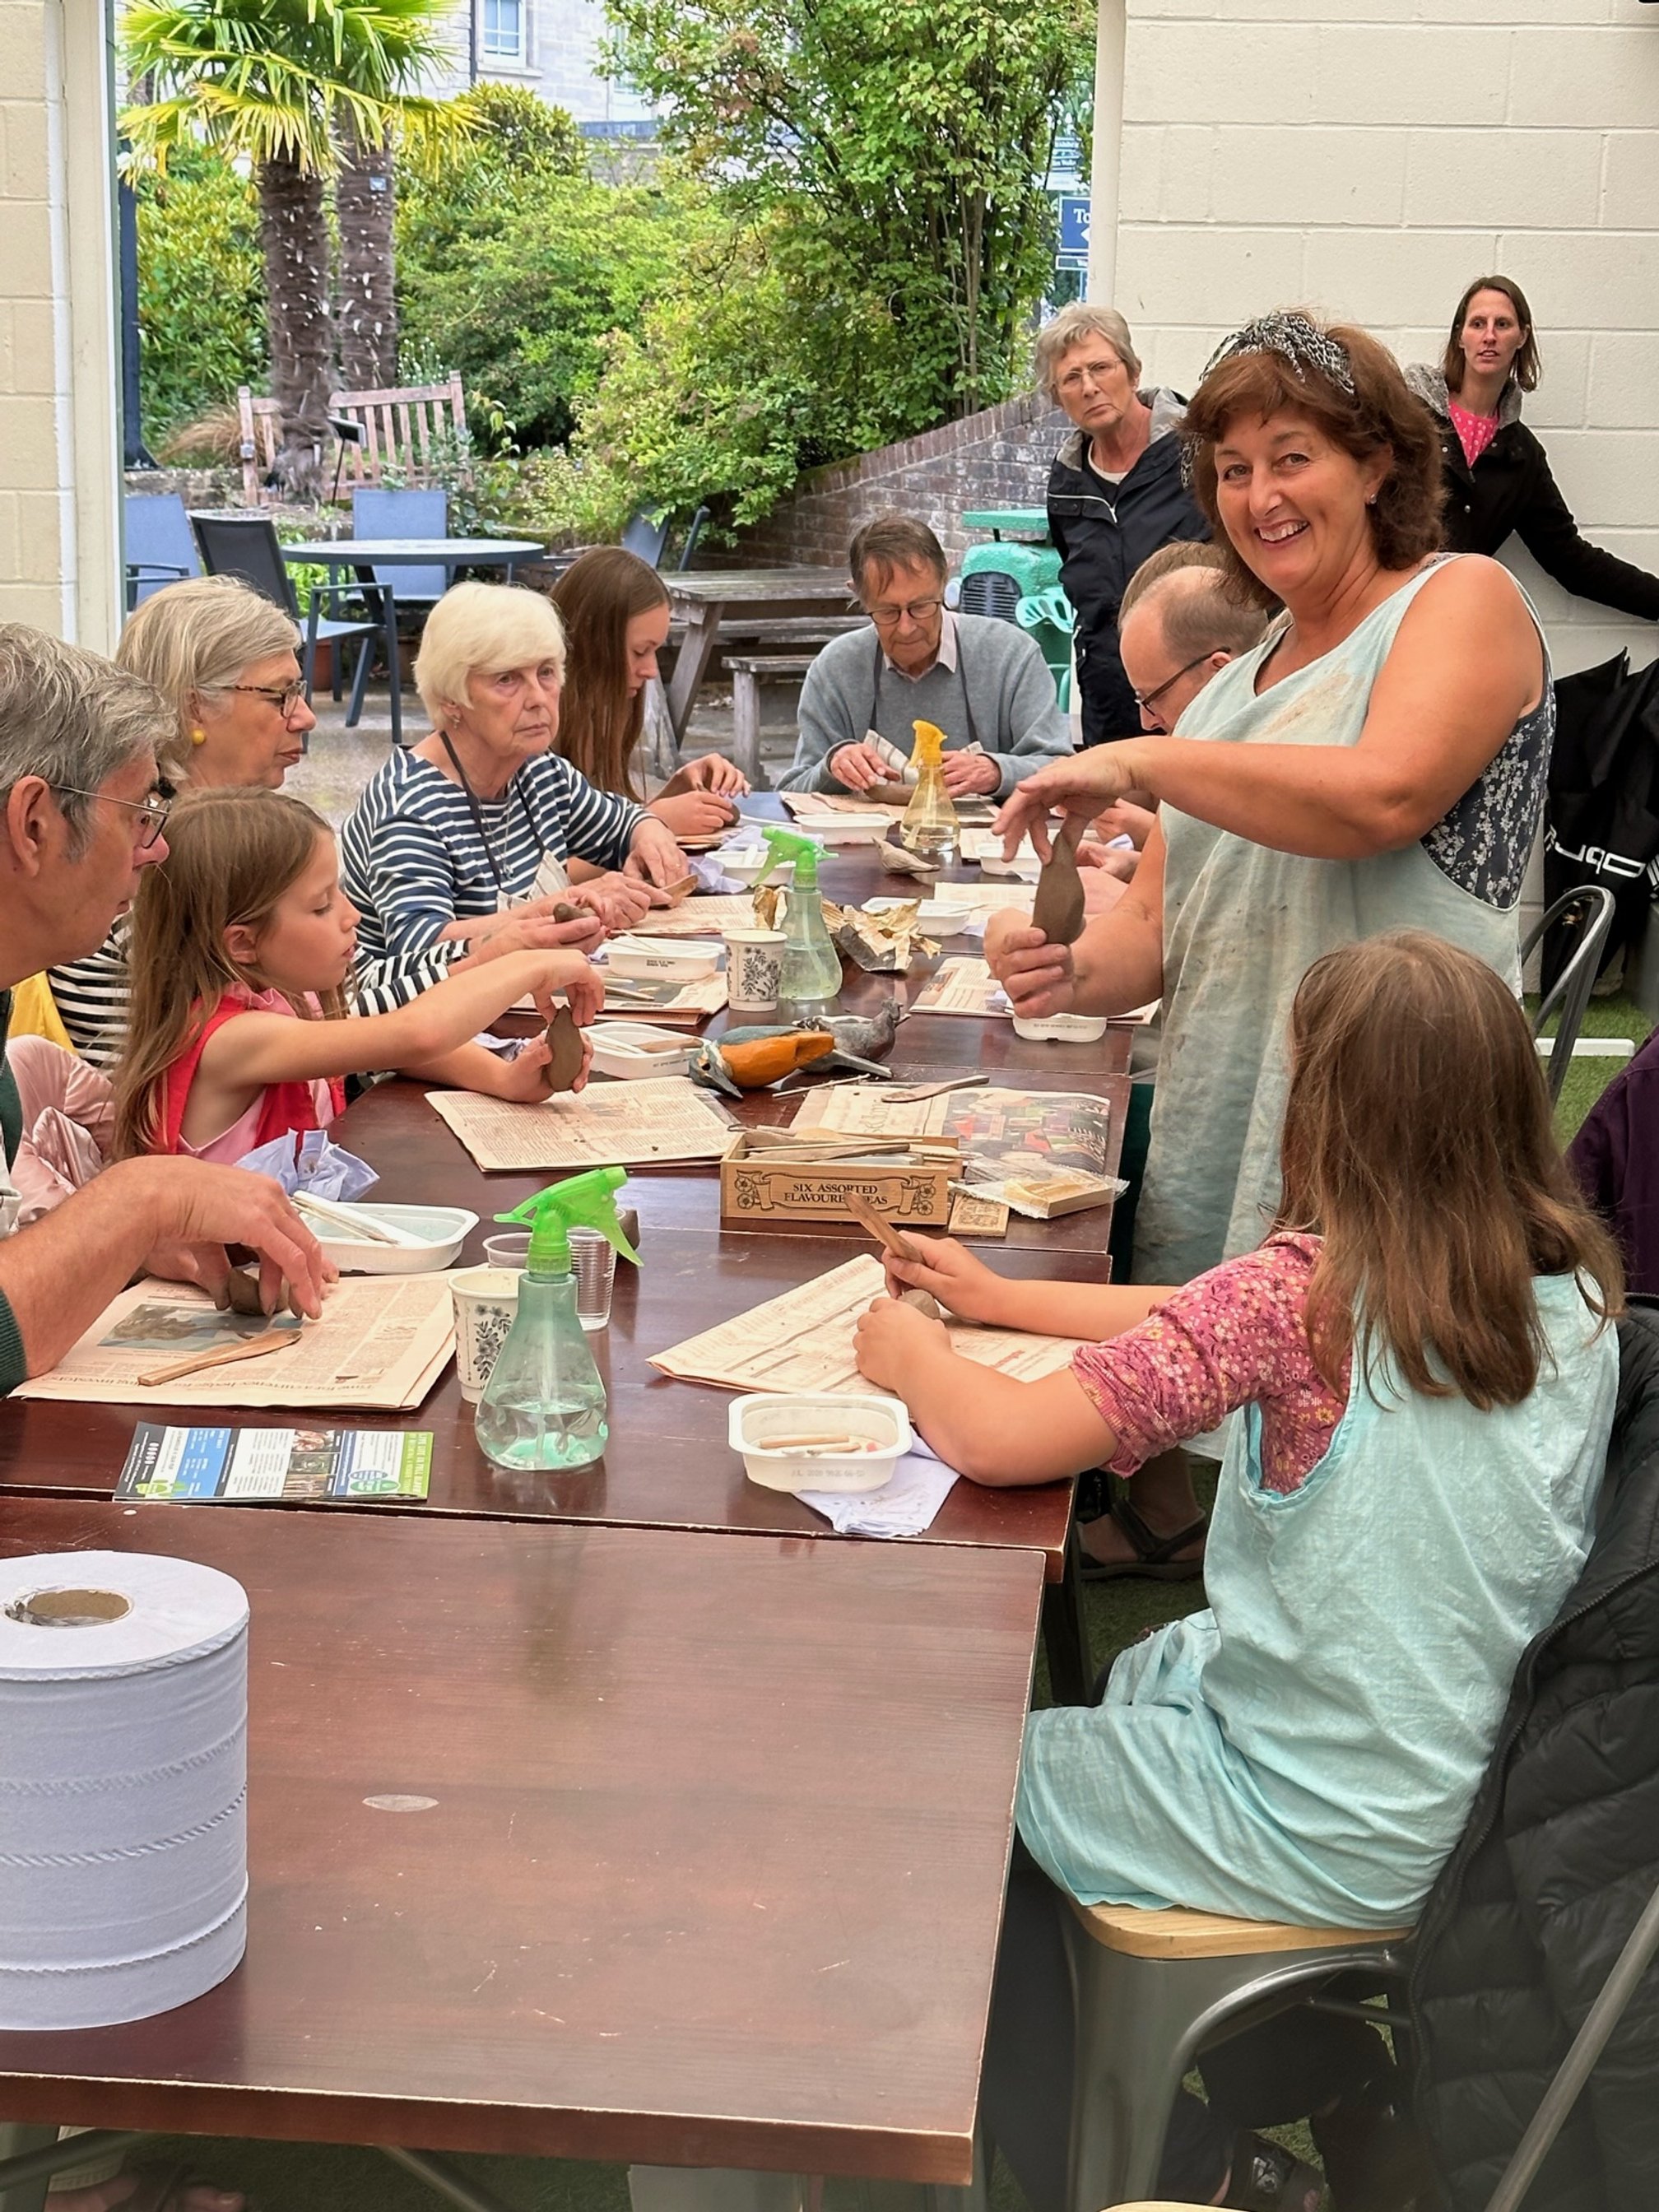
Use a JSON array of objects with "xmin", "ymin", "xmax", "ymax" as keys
[{"xmin": 0, "ymin": 1499, "xmax": 1039, "ymax": 2183}]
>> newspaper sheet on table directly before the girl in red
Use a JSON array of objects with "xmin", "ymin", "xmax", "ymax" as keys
[{"xmin": 427, "ymin": 1075, "xmax": 732, "ymax": 1173}]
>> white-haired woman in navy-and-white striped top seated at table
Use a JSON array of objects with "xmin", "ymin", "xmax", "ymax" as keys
[{"xmin": 341, "ymin": 584, "xmax": 685, "ymax": 978}]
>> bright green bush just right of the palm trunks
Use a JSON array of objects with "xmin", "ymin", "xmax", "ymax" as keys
[{"xmin": 398, "ymin": 86, "xmax": 726, "ymax": 447}]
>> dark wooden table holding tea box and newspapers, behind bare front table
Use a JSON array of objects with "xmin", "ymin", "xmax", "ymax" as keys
[{"xmin": 0, "ymin": 836, "xmax": 1128, "ymax": 1654}]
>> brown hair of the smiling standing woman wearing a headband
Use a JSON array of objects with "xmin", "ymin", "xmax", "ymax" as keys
[{"xmin": 1186, "ymin": 323, "xmax": 1444, "ymax": 613}]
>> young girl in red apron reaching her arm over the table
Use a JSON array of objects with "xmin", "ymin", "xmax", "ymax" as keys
[{"xmin": 115, "ymin": 788, "xmax": 604, "ymax": 1161}]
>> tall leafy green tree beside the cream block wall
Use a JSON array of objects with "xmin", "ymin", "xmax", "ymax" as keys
[{"xmin": 608, "ymin": 0, "xmax": 1095, "ymax": 427}]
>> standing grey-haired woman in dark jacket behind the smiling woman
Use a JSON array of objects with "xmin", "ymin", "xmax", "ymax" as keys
[{"xmin": 1038, "ymin": 301, "xmax": 1210, "ymax": 746}]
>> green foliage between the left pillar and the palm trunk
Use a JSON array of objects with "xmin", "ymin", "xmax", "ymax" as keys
[{"xmin": 137, "ymin": 148, "xmax": 266, "ymax": 444}]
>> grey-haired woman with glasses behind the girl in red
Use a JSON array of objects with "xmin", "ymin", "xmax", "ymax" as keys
[{"xmin": 51, "ymin": 575, "xmax": 583, "ymax": 1068}]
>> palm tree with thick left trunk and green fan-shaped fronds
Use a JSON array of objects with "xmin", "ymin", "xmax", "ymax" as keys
[{"xmin": 122, "ymin": 0, "xmax": 467, "ymax": 495}]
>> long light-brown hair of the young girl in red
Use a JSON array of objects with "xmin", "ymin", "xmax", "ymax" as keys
[{"xmin": 115, "ymin": 785, "xmax": 347, "ymax": 1157}]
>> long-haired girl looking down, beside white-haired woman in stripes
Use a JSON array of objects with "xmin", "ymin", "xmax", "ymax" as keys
[{"xmin": 551, "ymin": 546, "xmax": 750, "ymax": 839}]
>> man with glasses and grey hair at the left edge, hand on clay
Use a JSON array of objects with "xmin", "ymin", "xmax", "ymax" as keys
[{"xmin": 0, "ymin": 621, "xmax": 332, "ymax": 1393}]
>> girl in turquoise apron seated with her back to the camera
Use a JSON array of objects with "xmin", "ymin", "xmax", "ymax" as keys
[{"xmin": 858, "ymin": 932, "xmax": 1621, "ymax": 2212}]
